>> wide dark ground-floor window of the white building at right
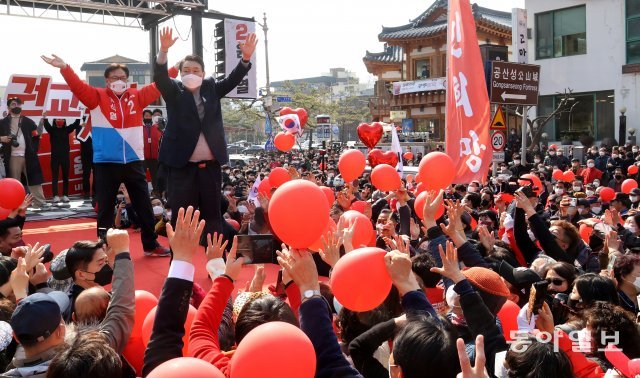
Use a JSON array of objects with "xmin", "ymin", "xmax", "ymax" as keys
[{"xmin": 538, "ymin": 91, "xmax": 615, "ymax": 141}]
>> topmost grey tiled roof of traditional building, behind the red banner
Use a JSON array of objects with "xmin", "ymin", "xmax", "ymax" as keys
[{"xmin": 378, "ymin": 0, "xmax": 511, "ymax": 41}]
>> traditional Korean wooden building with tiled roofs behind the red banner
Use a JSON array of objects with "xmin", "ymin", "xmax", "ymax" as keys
[{"xmin": 363, "ymin": 0, "xmax": 511, "ymax": 141}]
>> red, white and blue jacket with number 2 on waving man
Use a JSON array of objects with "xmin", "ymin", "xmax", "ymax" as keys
[{"xmin": 60, "ymin": 65, "xmax": 160, "ymax": 164}]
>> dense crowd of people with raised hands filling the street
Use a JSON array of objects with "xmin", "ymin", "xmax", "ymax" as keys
[{"xmin": 0, "ymin": 135, "xmax": 640, "ymax": 377}]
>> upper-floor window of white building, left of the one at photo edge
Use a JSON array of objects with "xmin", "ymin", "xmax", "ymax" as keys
[{"xmin": 535, "ymin": 5, "xmax": 584, "ymax": 59}]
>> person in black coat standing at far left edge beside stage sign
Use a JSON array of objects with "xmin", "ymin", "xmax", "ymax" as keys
[{"xmin": 0, "ymin": 97, "xmax": 47, "ymax": 208}]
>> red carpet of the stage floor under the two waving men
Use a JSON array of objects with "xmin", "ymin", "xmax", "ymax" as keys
[{"xmin": 23, "ymin": 218, "xmax": 279, "ymax": 297}]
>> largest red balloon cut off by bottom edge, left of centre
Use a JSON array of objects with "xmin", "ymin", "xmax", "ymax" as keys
[{"xmin": 231, "ymin": 322, "xmax": 316, "ymax": 378}]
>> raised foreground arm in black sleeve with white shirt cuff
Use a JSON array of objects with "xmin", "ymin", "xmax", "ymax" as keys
[{"xmin": 142, "ymin": 207, "xmax": 205, "ymax": 377}]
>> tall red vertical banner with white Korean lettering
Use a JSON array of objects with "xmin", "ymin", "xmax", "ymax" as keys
[{"xmin": 445, "ymin": 0, "xmax": 492, "ymax": 184}]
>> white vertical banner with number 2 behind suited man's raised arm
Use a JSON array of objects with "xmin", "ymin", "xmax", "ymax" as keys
[{"xmin": 224, "ymin": 18, "xmax": 258, "ymax": 98}]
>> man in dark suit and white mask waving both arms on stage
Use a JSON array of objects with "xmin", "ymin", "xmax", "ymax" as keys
[{"xmin": 153, "ymin": 28, "xmax": 257, "ymax": 245}]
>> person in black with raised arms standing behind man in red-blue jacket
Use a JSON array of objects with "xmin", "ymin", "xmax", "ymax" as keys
[{"xmin": 42, "ymin": 112, "xmax": 80, "ymax": 202}]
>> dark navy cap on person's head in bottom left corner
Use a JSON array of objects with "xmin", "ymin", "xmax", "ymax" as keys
[{"xmin": 11, "ymin": 291, "xmax": 69, "ymax": 343}]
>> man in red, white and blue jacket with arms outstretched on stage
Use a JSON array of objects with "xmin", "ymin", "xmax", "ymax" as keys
[{"xmin": 42, "ymin": 55, "xmax": 170, "ymax": 256}]
